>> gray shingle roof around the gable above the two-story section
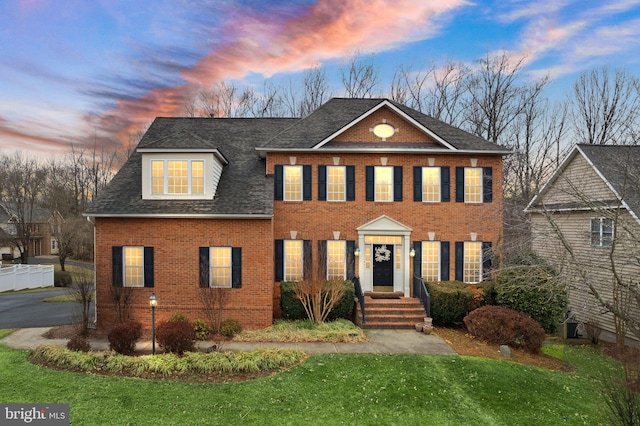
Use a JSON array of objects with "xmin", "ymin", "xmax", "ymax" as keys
[{"xmin": 261, "ymin": 98, "xmax": 508, "ymax": 153}]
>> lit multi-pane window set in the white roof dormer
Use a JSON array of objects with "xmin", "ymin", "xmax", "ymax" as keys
[{"xmin": 151, "ymin": 160, "xmax": 204, "ymax": 195}]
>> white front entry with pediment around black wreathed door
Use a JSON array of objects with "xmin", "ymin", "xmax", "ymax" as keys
[{"xmin": 357, "ymin": 215, "xmax": 411, "ymax": 297}]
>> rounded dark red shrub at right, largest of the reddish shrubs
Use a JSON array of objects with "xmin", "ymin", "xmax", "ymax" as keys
[{"xmin": 464, "ymin": 306, "xmax": 546, "ymax": 353}]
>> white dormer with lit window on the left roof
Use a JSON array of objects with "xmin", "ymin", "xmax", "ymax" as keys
[{"xmin": 140, "ymin": 149, "xmax": 227, "ymax": 200}]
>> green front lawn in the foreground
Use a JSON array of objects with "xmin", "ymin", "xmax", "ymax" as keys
[{"xmin": 0, "ymin": 345, "xmax": 619, "ymax": 425}]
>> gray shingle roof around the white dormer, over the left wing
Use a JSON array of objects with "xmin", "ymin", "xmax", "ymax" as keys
[{"xmin": 86, "ymin": 118, "xmax": 294, "ymax": 216}]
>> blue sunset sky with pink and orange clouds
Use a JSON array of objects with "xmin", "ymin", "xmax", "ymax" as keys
[{"xmin": 0, "ymin": 0, "xmax": 640, "ymax": 155}]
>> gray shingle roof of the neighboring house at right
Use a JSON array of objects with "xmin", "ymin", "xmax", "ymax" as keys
[{"xmin": 578, "ymin": 144, "xmax": 640, "ymax": 217}]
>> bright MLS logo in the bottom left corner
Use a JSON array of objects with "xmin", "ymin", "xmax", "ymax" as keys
[{"xmin": 0, "ymin": 404, "xmax": 69, "ymax": 426}]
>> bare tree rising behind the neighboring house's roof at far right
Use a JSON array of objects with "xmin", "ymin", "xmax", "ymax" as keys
[{"xmin": 570, "ymin": 67, "xmax": 640, "ymax": 145}]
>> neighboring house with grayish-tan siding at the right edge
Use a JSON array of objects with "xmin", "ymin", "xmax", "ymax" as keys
[{"xmin": 526, "ymin": 145, "xmax": 640, "ymax": 340}]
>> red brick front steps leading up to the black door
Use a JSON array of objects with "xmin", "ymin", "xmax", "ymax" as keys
[{"xmin": 356, "ymin": 292, "xmax": 427, "ymax": 329}]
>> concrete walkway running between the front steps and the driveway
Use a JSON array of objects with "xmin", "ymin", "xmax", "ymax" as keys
[{"xmin": 0, "ymin": 327, "xmax": 457, "ymax": 355}]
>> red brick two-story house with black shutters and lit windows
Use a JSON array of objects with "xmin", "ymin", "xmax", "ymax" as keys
[{"xmin": 87, "ymin": 99, "xmax": 508, "ymax": 328}]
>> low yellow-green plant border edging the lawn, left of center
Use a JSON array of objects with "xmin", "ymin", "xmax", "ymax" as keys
[{"xmin": 29, "ymin": 345, "xmax": 306, "ymax": 377}]
